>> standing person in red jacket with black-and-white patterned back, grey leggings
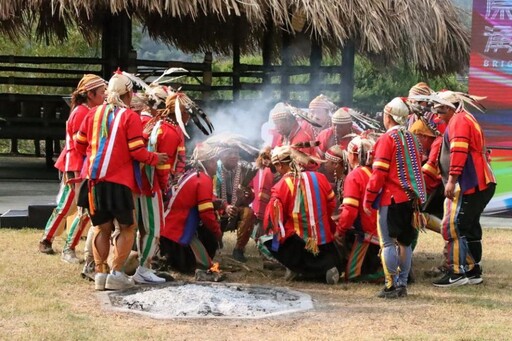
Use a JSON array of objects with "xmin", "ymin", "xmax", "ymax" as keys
[{"xmin": 363, "ymin": 97, "xmax": 426, "ymax": 298}]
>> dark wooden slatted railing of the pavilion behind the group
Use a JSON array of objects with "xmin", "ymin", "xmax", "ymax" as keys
[{"xmin": 0, "ymin": 53, "xmax": 342, "ymax": 164}]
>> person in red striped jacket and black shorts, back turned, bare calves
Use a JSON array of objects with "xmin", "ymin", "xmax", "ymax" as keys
[{"xmin": 75, "ymin": 70, "xmax": 168, "ymax": 290}]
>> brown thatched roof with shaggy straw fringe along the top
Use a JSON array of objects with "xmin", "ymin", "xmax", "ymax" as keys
[{"xmin": 0, "ymin": 0, "xmax": 469, "ymax": 73}]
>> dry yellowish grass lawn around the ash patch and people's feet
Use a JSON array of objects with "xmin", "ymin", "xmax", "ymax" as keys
[{"xmin": 0, "ymin": 229, "xmax": 512, "ymax": 340}]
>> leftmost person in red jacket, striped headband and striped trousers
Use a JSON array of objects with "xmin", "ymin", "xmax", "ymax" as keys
[{"xmin": 39, "ymin": 74, "xmax": 106, "ymax": 264}]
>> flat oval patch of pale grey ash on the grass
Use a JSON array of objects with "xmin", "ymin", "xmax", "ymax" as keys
[{"xmin": 98, "ymin": 282, "xmax": 313, "ymax": 319}]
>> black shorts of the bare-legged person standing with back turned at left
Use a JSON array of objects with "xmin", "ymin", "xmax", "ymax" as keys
[{"xmin": 77, "ymin": 181, "xmax": 135, "ymax": 226}]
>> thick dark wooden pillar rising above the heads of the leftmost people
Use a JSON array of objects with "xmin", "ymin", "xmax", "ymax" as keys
[{"xmin": 101, "ymin": 12, "xmax": 136, "ymax": 80}]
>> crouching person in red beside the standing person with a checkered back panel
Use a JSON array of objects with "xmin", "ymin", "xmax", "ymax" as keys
[{"xmin": 336, "ymin": 136, "xmax": 384, "ymax": 282}]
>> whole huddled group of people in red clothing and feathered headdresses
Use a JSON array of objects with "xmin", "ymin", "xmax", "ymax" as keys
[{"xmin": 39, "ymin": 70, "xmax": 496, "ymax": 298}]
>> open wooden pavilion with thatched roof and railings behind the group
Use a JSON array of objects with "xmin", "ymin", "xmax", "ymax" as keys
[{"xmin": 0, "ymin": 0, "xmax": 469, "ymax": 164}]
